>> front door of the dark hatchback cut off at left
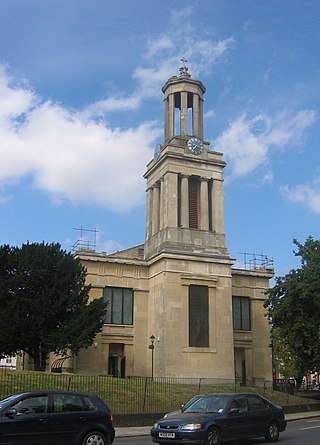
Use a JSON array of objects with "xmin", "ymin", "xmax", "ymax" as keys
[{"xmin": 0, "ymin": 394, "xmax": 50, "ymax": 445}]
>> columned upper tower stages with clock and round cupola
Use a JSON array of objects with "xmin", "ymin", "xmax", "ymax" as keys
[{"xmin": 145, "ymin": 59, "xmax": 228, "ymax": 259}]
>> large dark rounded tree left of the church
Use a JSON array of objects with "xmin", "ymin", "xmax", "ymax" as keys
[{"xmin": 0, "ymin": 243, "xmax": 106, "ymax": 371}]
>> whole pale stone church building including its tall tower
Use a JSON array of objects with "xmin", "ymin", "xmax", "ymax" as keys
[{"xmin": 73, "ymin": 62, "xmax": 273, "ymax": 385}]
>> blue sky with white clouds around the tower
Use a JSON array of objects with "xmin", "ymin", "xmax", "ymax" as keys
[{"xmin": 0, "ymin": 0, "xmax": 320, "ymax": 276}]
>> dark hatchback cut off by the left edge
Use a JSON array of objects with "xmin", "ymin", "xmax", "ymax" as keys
[{"xmin": 0, "ymin": 391, "xmax": 115, "ymax": 445}]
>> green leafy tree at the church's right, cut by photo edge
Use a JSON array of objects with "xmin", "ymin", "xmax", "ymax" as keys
[{"xmin": 265, "ymin": 236, "xmax": 320, "ymax": 386}]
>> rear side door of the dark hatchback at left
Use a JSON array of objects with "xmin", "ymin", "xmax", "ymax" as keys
[{"xmin": 51, "ymin": 393, "xmax": 95, "ymax": 445}]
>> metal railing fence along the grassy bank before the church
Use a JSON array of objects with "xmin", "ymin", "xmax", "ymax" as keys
[{"xmin": 0, "ymin": 369, "xmax": 302, "ymax": 414}]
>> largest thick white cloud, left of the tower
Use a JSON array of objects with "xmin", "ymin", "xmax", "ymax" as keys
[{"xmin": 0, "ymin": 65, "xmax": 161, "ymax": 212}]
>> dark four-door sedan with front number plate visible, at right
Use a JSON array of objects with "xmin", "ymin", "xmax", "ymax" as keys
[{"xmin": 151, "ymin": 393, "xmax": 287, "ymax": 445}]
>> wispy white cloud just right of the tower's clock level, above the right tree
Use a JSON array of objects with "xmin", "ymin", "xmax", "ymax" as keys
[{"xmin": 213, "ymin": 110, "xmax": 317, "ymax": 181}]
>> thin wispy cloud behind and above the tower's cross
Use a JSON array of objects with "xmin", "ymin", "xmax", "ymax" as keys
[{"xmin": 89, "ymin": 7, "xmax": 235, "ymax": 115}]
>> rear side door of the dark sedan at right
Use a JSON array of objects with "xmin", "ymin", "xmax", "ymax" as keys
[{"xmin": 247, "ymin": 394, "xmax": 270, "ymax": 436}]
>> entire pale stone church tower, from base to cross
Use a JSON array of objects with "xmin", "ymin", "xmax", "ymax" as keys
[{"xmin": 144, "ymin": 60, "xmax": 234, "ymax": 378}]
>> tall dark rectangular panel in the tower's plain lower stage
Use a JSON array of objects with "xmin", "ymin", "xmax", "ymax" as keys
[{"xmin": 189, "ymin": 285, "xmax": 209, "ymax": 348}]
